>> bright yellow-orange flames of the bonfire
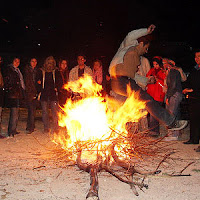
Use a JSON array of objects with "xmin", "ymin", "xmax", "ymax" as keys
[{"xmin": 53, "ymin": 76, "xmax": 147, "ymax": 160}]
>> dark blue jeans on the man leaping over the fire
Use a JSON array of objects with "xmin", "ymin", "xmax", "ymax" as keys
[{"xmin": 111, "ymin": 76, "xmax": 175, "ymax": 126}]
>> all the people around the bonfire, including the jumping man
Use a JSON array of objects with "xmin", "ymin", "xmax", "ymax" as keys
[{"xmin": 0, "ymin": 25, "xmax": 200, "ymax": 151}]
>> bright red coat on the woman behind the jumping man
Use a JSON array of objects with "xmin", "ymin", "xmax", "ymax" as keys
[{"xmin": 146, "ymin": 68, "xmax": 166, "ymax": 102}]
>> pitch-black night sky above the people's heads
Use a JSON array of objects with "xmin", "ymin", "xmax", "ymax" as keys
[{"xmin": 0, "ymin": 0, "xmax": 200, "ymax": 67}]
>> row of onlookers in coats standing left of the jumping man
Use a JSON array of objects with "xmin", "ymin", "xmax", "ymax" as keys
[{"xmin": 0, "ymin": 55, "xmax": 110, "ymax": 138}]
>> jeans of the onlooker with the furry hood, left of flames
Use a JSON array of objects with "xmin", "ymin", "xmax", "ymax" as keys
[{"xmin": 41, "ymin": 101, "xmax": 58, "ymax": 130}]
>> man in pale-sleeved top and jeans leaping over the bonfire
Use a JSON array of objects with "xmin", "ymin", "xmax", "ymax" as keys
[{"xmin": 109, "ymin": 24, "xmax": 187, "ymax": 130}]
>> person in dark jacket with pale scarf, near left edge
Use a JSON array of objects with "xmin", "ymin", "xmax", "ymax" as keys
[{"xmin": 4, "ymin": 58, "xmax": 25, "ymax": 136}]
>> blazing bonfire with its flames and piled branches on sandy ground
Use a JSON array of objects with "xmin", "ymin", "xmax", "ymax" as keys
[{"xmin": 53, "ymin": 76, "xmax": 166, "ymax": 199}]
